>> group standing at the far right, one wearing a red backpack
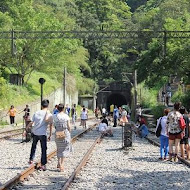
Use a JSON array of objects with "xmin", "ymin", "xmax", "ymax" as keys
[{"xmin": 156, "ymin": 102, "xmax": 190, "ymax": 162}]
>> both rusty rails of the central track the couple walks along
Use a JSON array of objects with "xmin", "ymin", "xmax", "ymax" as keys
[{"xmin": 0, "ymin": 121, "xmax": 101, "ymax": 190}]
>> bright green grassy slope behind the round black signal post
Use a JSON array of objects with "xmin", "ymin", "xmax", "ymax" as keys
[{"xmin": 0, "ymin": 72, "xmax": 61, "ymax": 109}]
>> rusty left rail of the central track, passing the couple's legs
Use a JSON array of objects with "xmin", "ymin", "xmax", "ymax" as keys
[{"xmin": 0, "ymin": 123, "xmax": 97, "ymax": 190}]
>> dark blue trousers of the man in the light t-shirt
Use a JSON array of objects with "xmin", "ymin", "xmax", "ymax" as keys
[{"xmin": 30, "ymin": 135, "xmax": 47, "ymax": 165}]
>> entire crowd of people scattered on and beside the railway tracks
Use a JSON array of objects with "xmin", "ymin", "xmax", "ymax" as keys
[{"xmin": 8, "ymin": 100, "xmax": 190, "ymax": 171}]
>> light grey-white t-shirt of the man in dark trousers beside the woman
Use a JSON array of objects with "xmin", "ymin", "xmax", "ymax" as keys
[{"xmin": 32, "ymin": 110, "xmax": 52, "ymax": 136}]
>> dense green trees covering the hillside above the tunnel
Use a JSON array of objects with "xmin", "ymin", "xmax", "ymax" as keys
[{"xmin": 0, "ymin": 0, "xmax": 190, "ymax": 108}]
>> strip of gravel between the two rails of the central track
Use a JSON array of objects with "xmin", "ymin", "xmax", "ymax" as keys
[{"xmin": 12, "ymin": 129, "xmax": 99, "ymax": 190}]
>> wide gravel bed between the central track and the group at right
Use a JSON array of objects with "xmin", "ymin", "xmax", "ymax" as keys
[{"xmin": 69, "ymin": 127, "xmax": 190, "ymax": 190}]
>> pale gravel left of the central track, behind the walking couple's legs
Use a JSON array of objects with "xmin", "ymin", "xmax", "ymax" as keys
[{"xmin": 0, "ymin": 120, "xmax": 95, "ymax": 185}]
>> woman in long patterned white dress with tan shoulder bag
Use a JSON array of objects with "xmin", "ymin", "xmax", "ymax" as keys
[{"xmin": 53, "ymin": 104, "xmax": 72, "ymax": 172}]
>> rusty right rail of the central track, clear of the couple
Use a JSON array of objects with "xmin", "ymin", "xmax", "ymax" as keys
[{"xmin": 62, "ymin": 136, "xmax": 102, "ymax": 190}]
